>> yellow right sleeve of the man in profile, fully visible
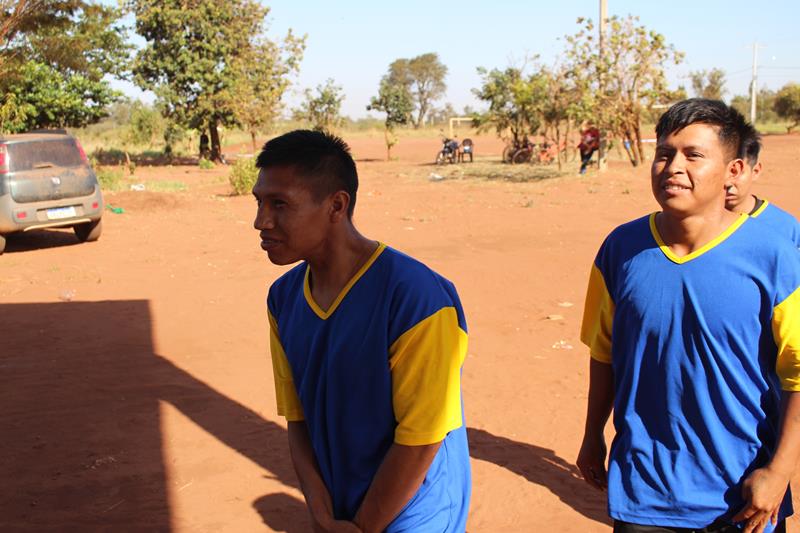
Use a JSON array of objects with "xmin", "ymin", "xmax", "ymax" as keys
[{"xmin": 389, "ymin": 307, "xmax": 467, "ymax": 446}]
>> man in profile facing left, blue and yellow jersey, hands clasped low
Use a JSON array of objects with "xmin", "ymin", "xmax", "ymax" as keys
[{"xmin": 253, "ymin": 130, "xmax": 471, "ymax": 533}]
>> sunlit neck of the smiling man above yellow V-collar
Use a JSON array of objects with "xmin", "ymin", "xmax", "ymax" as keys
[{"xmin": 656, "ymin": 209, "xmax": 739, "ymax": 257}]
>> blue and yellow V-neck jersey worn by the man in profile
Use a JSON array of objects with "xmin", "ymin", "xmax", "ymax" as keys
[{"xmin": 267, "ymin": 244, "xmax": 471, "ymax": 532}]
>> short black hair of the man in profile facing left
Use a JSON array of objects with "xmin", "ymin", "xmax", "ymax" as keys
[{"xmin": 256, "ymin": 130, "xmax": 358, "ymax": 218}]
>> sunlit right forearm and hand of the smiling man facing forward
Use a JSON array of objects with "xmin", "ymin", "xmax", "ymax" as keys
[{"xmin": 733, "ymin": 391, "xmax": 800, "ymax": 533}]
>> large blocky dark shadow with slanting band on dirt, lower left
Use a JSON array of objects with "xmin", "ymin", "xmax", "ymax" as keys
[{"xmin": 0, "ymin": 300, "xmax": 308, "ymax": 531}]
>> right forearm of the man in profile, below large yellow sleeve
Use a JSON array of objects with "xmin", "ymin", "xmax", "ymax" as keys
[{"xmin": 354, "ymin": 442, "xmax": 442, "ymax": 533}]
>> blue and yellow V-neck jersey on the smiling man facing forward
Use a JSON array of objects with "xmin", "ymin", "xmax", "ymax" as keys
[{"xmin": 581, "ymin": 215, "xmax": 800, "ymax": 528}]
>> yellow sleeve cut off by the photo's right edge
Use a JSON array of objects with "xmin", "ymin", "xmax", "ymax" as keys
[{"xmin": 772, "ymin": 288, "xmax": 800, "ymax": 392}]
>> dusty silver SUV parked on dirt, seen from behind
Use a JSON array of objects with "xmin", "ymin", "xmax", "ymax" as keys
[{"xmin": 0, "ymin": 130, "xmax": 103, "ymax": 254}]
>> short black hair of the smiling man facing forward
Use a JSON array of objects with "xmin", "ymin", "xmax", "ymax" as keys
[{"xmin": 656, "ymin": 98, "xmax": 752, "ymax": 157}]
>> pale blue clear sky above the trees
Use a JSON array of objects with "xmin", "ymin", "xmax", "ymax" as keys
[{"xmin": 112, "ymin": 0, "xmax": 800, "ymax": 118}]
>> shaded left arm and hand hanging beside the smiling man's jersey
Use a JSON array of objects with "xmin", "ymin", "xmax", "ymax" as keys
[{"xmin": 577, "ymin": 357, "xmax": 614, "ymax": 490}]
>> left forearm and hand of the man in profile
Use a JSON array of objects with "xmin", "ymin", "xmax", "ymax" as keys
[{"xmin": 288, "ymin": 421, "xmax": 360, "ymax": 533}]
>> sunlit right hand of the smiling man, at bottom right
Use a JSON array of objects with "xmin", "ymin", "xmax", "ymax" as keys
[{"xmin": 733, "ymin": 466, "xmax": 791, "ymax": 533}]
